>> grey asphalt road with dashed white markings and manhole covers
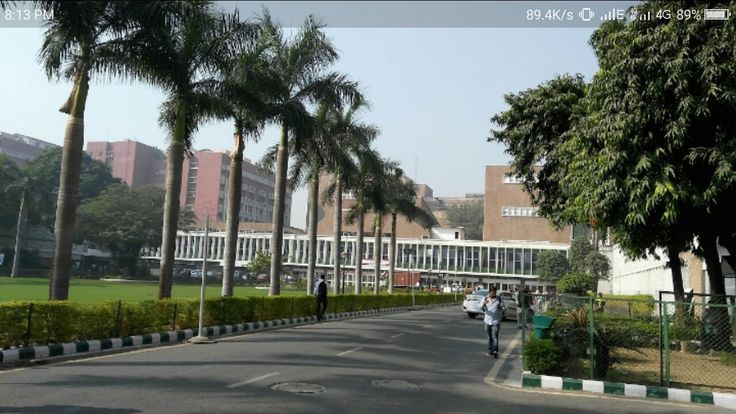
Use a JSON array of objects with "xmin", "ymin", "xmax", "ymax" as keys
[{"xmin": 0, "ymin": 306, "xmax": 725, "ymax": 414}]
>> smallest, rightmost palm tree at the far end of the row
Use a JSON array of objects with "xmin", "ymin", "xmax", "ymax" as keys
[{"xmin": 388, "ymin": 176, "xmax": 437, "ymax": 293}]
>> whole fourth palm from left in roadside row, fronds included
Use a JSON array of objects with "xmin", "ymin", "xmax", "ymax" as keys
[{"xmin": 260, "ymin": 17, "xmax": 357, "ymax": 295}]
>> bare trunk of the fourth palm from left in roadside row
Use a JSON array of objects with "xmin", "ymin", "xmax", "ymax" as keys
[{"xmin": 268, "ymin": 124, "xmax": 289, "ymax": 296}]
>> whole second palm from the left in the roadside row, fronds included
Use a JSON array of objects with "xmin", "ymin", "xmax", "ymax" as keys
[{"xmin": 123, "ymin": 2, "xmax": 257, "ymax": 299}]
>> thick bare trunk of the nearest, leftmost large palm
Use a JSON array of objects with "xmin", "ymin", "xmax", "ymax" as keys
[{"xmin": 49, "ymin": 69, "xmax": 89, "ymax": 300}]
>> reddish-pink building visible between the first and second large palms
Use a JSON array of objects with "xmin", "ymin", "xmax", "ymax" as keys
[{"xmin": 87, "ymin": 140, "xmax": 166, "ymax": 187}]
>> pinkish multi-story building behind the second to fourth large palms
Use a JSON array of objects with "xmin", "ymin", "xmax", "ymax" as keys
[{"xmin": 180, "ymin": 150, "xmax": 291, "ymax": 226}]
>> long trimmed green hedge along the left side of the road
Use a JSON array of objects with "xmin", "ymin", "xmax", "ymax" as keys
[{"xmin": 0, "ymin": 294, "xmax": 455, "ymax": 349}]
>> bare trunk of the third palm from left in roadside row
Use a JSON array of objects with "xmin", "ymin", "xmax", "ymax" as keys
[{"xmin": 222, "ymin": 119, "xmax": 245, "ymax": 296}]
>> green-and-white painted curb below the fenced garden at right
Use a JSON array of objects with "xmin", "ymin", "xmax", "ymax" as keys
[{"xmin": 521, "ymin": 371, "xmax": 736, "ymax": 410}]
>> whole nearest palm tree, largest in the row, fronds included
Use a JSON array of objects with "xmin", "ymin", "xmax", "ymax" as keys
[{"xmin": 37, "ymin": 1, "xmax": 155, "ymax": 300}]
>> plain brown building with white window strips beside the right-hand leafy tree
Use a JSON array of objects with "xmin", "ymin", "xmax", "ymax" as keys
[{"xmin": 483, "ymin": 165, "xmax": 572, "ymax": 243}]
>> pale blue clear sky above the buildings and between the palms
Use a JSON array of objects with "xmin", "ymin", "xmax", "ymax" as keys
[{"xmin": 0, "ymin": 6, "xmax": 597, "ymax": 227}]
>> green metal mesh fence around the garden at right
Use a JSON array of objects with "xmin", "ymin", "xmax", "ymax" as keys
[{"xmin": 520, "ymin": 292, "xmax": 736, "ymax": 391}]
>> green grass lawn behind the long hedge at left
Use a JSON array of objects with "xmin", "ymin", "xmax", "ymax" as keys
[{"xmin": 0, "ymin": 276, "xmax": 306, "ymax": 303}]
